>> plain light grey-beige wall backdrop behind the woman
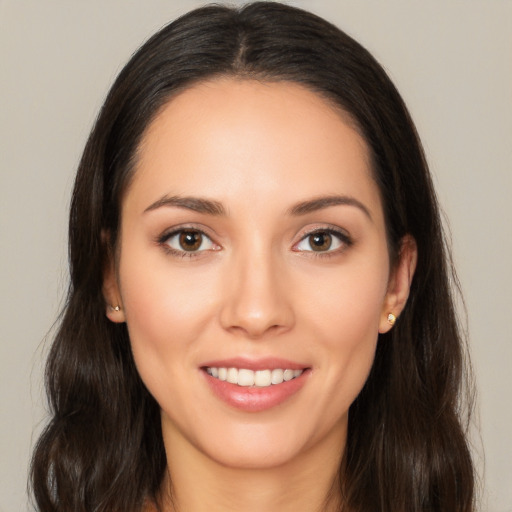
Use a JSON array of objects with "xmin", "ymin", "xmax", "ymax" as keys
[{"xmin": 0, "ymin": 0, "xmax": 512, "ymax": 512}]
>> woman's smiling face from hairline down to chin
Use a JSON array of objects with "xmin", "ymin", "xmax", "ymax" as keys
[{"xmin": 105, "ymin": 79, "xmax": 408, "ymax": 467}]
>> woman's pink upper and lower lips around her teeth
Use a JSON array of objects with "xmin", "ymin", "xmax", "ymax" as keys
[{"xmin": 202, "ymin": 358, "xmax": 311, "ymax": 412}]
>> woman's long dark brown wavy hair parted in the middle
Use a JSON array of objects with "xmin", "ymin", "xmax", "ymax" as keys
[{"xmin": 31, "ymin": 2, "xmax": 474, "ymax": 512}]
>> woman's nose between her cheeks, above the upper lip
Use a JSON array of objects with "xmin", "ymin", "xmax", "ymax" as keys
[{"xmin": 220, "ymin": 251, "xmax": 295, "ymax": 339}]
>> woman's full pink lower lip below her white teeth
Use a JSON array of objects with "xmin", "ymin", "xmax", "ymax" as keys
[{"xmin": 203, "ymin": 369, "xmax": 310, "ymax": 412}]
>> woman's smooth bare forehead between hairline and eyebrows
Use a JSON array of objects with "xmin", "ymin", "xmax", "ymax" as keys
[{"xmin": 128, "ymin": 78, "xmax": 379, "ymax": 219}]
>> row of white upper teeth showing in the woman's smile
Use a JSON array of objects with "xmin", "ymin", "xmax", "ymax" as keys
[{"xmin": 206, "ymin": 366, "xmax": 304, "ymax": 388}]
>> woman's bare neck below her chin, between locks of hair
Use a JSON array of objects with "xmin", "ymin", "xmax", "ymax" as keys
[{"xmin": 158, "ymin": 420, "xmax": 345, "ymax": 512}]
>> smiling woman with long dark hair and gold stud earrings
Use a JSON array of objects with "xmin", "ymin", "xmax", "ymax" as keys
[{"xmin": 32, "ymin": 3, "xmax": 473, "ymax": 512}]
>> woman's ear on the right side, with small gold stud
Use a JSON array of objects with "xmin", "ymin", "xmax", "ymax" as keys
[{"xmin": 379, "ymin": 235, "xmax": 418, "ymax": 333}]
